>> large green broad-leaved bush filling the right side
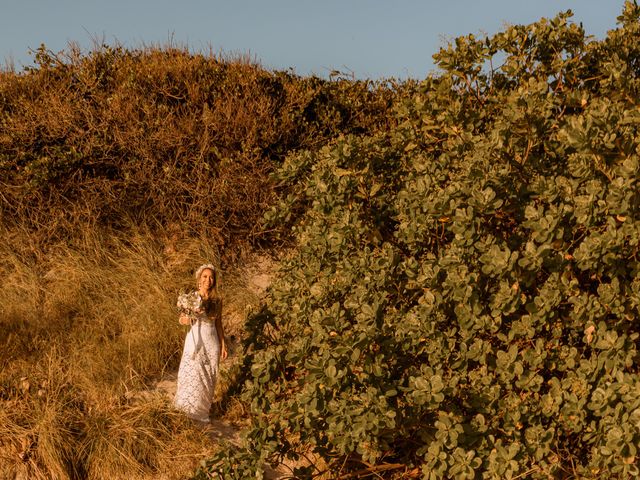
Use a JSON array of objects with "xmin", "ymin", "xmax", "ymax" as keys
[{"xmin": 199, "ymin": 2, "xmax": 640, "ymax": 479}]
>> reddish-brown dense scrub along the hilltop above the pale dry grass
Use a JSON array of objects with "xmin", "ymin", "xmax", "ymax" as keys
[{"xmin": 0, "ymin": 46, "xmax": 396, "ymax": 258}]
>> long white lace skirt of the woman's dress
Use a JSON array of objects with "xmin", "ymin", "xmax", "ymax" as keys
[{"xmin": 173, "ymin": 317, "xmax": 220, "ymax": 422}]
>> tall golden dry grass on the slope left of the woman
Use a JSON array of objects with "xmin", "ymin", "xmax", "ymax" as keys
[{"xmin": 0, "ymin": 223, "xmax": 238, "ymax": 479}]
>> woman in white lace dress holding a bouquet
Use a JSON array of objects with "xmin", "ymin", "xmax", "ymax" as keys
[{"xmin": 174, "ymin": 264, "xmax": 227, "ymax": 423}]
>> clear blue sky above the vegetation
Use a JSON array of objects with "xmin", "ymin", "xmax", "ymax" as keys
[{"xmin": 0, "ymin": 0, "xmax": 624, "ymax": 78}]
